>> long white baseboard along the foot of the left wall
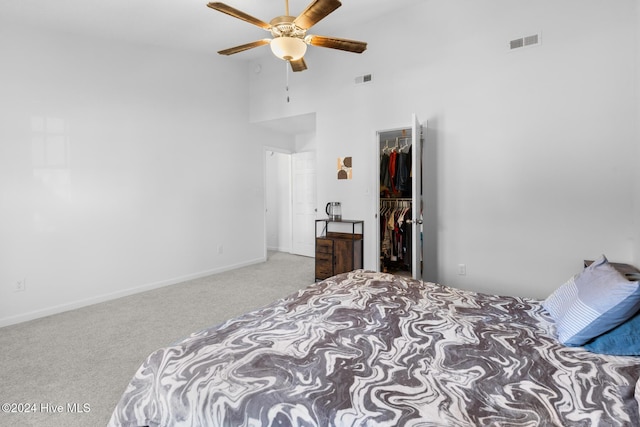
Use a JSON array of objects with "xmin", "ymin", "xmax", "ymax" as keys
[{"xmin": 0, "ymin": 257, "xmax": 266, "ymax": 328}]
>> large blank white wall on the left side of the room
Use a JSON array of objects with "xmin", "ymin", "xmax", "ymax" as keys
[{"xmin": 0, "ymin": 25, "xmax": 288, "ymax": 326}]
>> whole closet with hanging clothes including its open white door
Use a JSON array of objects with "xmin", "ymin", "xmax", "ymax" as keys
[{"xmin": 376, "ymin": 116, "xmax": 422, "ymax": 278}]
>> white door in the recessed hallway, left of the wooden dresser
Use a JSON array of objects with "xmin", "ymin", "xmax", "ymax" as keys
[{"xmin": 291, "ymin": 151, "xmax": 316, "ymax": 257}]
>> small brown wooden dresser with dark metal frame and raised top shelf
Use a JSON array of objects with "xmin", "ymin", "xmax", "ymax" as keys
[{"xmin": 316, "ymin": 219, "xmax": 364, "ymax": 280}]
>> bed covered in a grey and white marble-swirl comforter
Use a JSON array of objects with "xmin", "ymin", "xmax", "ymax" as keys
[{"xmin": 109, "ymin": 270, "xmax": 640, "ymax": 427}]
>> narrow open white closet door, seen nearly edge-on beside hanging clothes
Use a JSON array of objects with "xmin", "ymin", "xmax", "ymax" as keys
[{"xmin": 411, "ymin": 114, "xmax": 423, "ymax": 279}]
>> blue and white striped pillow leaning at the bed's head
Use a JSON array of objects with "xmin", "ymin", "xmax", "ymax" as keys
[{"xmin": 542, "ymin": 255, "xmax": 640, "ymax": 346}]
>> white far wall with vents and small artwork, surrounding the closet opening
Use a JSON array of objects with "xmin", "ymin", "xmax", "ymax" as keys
[{"xmin": 250, "ymin": 0, "xmax": 638, "ymax": 297}]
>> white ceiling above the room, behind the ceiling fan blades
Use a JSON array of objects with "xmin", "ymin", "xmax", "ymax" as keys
[{"xmin": 0, "ymin": 0, "xmax": 420, "ymax": 60}]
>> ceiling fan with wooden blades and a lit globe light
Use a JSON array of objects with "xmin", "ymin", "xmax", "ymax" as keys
[{"xmin": 207, "ymin": 0, "xmax": 367, "ymax": 71}]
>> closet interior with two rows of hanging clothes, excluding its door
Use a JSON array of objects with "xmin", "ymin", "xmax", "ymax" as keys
[{"xmin": 378, "ymin": 128, "xmax": 413, "ymax": 276}]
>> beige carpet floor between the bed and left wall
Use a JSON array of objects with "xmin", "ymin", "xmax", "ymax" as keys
[{"xmin": 0, "ymin": 252, "xmax": 314, "ymax": 427}]
